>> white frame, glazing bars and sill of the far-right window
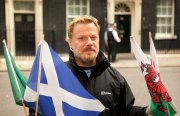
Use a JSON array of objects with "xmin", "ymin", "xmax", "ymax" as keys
[{"xmin": 155, "ymin": 0, "xmax": 177, "ymax": 40}]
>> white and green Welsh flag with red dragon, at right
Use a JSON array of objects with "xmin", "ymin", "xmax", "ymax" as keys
[{"xmin": 131, "ymin": 38, "xmax": 176, "ymax": 116}]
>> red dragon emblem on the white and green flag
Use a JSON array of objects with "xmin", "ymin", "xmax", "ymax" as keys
[{"xmin": 141, "ymin": 63, "xmax": 172, "ymax": 113}]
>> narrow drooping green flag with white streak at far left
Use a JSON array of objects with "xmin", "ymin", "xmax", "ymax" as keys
[{"xmin": 3, "ymin": 40, "xmax": 27, "ymax": 105}]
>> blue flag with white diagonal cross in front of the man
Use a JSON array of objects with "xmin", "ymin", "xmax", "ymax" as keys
[{"xmin": 24, "ymin": 41, "xmax": 105, "ymax": 116}]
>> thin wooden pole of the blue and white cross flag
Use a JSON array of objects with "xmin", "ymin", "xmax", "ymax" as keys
[{"xmin": 35, "ymin": 35, "xmax": 44, "ymax": 116}]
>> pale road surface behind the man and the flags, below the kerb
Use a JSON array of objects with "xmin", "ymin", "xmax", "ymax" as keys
[{"xmin": 0, "ymin": 67, "xmax": 180, "ymax": 116}]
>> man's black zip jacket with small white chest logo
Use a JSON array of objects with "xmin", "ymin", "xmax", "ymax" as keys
[{"xmin": 66, "ymin": 51, "xmax": 146, "ymax": 116}]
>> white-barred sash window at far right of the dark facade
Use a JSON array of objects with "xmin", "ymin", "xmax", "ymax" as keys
[{"xmin": 155, "ymin": 0, "xmax": 176, "ymax": 39}]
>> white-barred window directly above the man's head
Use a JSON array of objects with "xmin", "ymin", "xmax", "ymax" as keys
[{"xmin": 66, "ymin": 0, "xmax": 89, "ymax": 24}]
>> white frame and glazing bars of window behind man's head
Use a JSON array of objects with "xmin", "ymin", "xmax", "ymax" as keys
[{"xmin": 66, "ymin": 0, "xmax": 90, "ymax": 33}]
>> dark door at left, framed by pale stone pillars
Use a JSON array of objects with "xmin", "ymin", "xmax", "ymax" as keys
[{"xmin": 14, "ymin": 14, "xmax": 35, "ymax": 56}]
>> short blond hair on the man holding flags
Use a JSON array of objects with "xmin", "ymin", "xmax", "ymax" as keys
[{"xmin": 67, "ymin": 16, "xmax": 100, "ymax": 39}]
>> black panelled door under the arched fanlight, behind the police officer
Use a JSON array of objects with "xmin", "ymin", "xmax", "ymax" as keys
[{"xmin": 115, "ymin": 15, "xmax": 131, "ymax": 53}]
